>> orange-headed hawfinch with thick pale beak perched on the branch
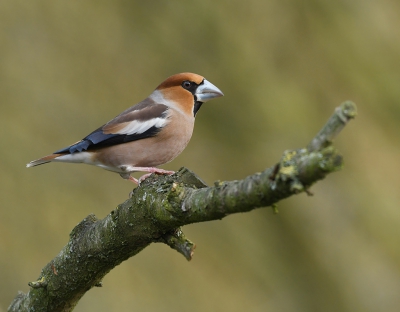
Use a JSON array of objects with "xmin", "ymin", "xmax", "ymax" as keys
[{"xmin": 26, "ymin": 73, "xmax": 224, "ymax": 184}]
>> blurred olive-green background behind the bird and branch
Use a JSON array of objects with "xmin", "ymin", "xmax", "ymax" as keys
[{"xmin": 0, "ymin": 0, "xmax": 400, "ymax": 312}]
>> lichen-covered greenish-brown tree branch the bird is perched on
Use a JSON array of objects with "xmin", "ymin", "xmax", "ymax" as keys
[{"xmin": 8, "ymin": 102, "xmax": 356, "ymax": 311}]
